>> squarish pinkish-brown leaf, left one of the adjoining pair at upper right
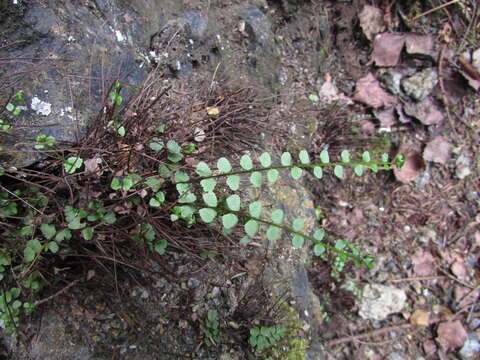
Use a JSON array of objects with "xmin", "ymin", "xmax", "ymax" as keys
[{"xmin": 372, "ymin": 33, "xmax": 405, "ymax": 66}]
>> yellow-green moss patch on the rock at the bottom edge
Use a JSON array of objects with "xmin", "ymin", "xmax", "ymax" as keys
[{"xmin": 259, "ymin": 302, "xmax": 310, "ymax": 360}]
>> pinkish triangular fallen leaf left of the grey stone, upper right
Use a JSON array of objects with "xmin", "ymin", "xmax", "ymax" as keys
[{"xmin": 353, "ymin": 73, "xmax": 397, "ymax": 108}]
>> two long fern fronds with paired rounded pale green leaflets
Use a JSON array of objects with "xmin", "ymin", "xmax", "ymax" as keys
[{"xmin": 146, "ymin": 145, "xmax": 404, "ymax": 270}]
